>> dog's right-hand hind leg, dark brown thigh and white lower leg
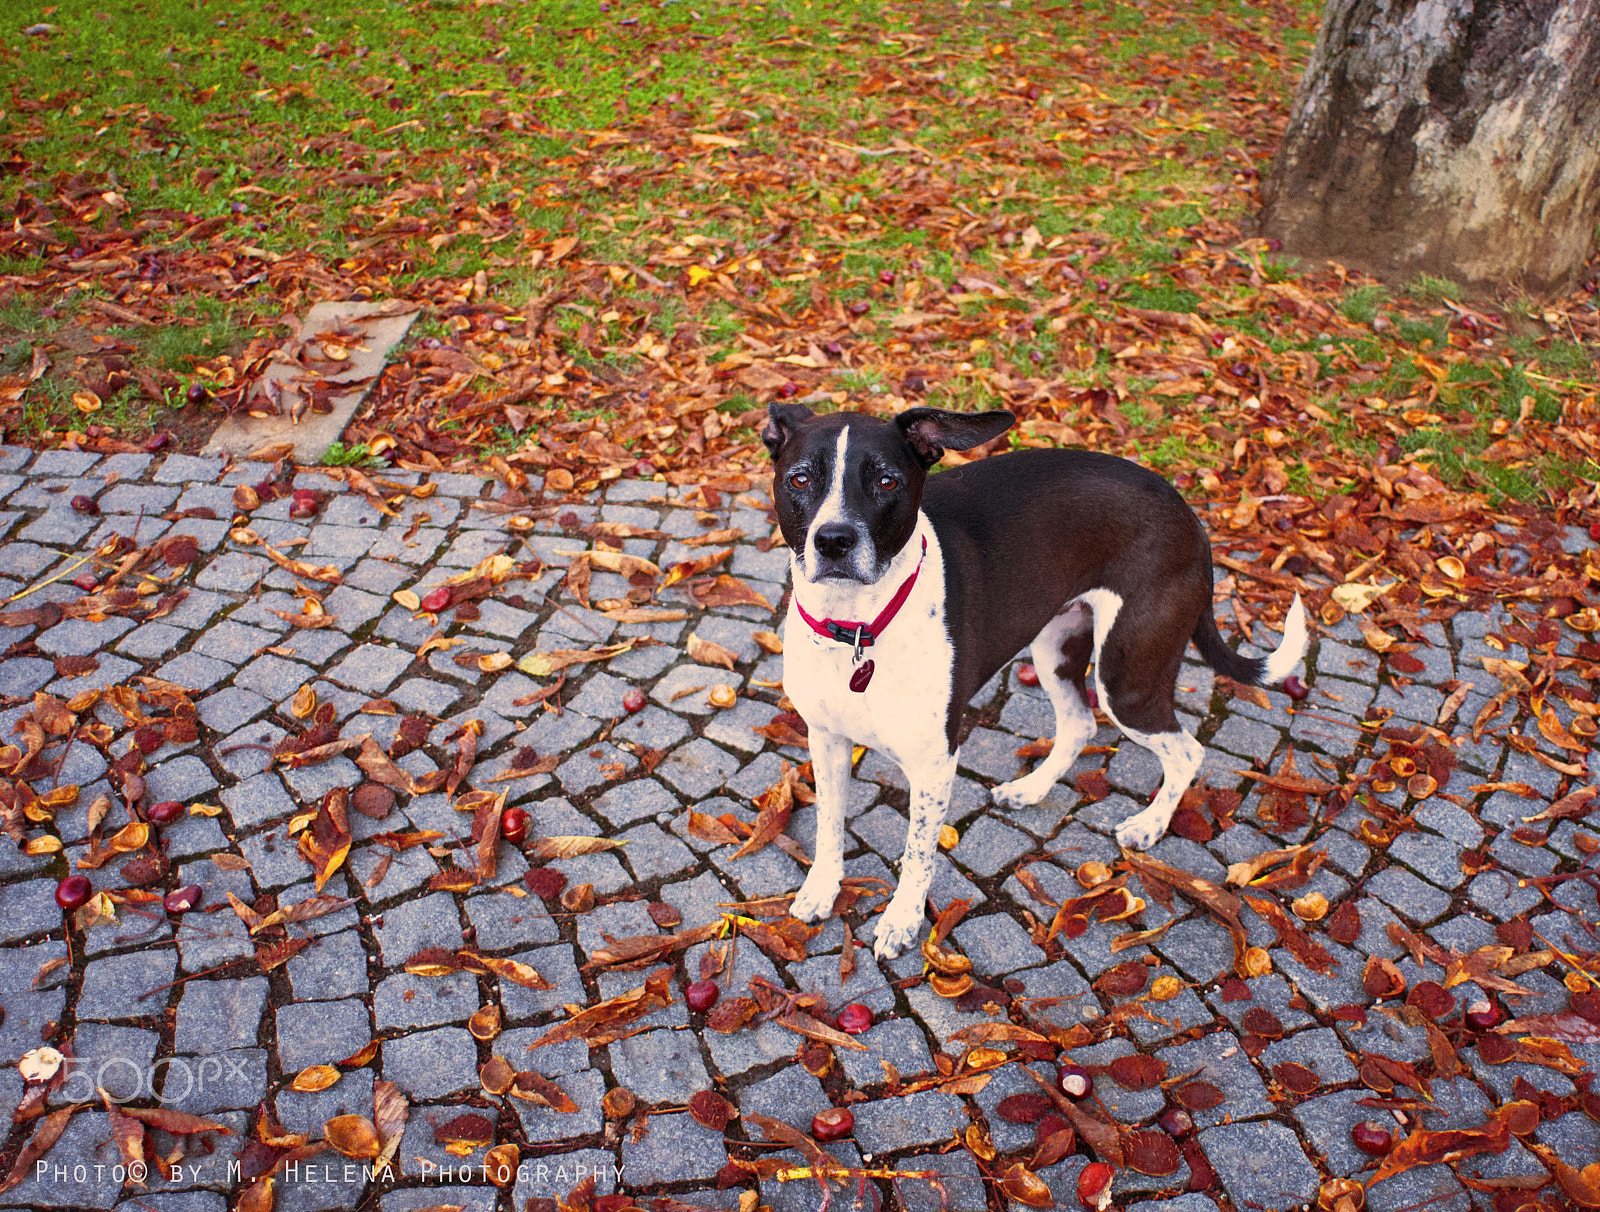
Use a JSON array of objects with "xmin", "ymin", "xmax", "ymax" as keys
[{"xmin": 1083, "ymin": 590, "xmax": 1205, "ymax": 851}]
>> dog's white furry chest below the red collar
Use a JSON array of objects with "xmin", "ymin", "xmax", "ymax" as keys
[{"xmin": 784, "ymin": 552, "xmax": 955, "ymax": 754}]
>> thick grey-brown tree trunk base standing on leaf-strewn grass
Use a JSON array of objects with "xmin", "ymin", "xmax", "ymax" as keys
[{"xmin": 1261, "ymin": 0, "xmax": 1600, "ymax": 294}]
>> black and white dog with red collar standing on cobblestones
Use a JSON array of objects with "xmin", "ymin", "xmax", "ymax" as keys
[{"xmin": 762, "ymin": 403, "xmax": 1307, "ymax": 958}]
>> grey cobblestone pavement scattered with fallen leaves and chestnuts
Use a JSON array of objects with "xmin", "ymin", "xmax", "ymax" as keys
[{"xmin": 0, "ymin": 448, "xmax": 1600, "ymax": 1212}]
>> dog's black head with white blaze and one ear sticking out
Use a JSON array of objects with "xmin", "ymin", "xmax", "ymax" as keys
[{"xmin": 762, "ymin": 403, "xmax": 1016, "ymax": 585}]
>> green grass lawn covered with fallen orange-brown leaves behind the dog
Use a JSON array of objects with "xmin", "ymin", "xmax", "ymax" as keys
[{"xmin": 0, "ymin": 0, "xmax": 1600, "ymax": 504}]
